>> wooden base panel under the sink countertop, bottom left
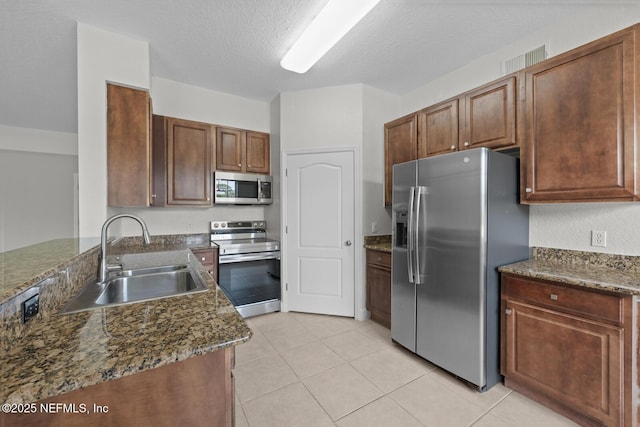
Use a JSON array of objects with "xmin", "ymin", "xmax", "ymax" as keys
[{"xmin": 0, "ymin": 347, "xmax": 235, "ymax": 427}]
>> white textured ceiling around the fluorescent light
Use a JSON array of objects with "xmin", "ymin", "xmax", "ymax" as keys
[{"xmin": 0, "ymin": 0, "xmax": 637, "ymax": 132}]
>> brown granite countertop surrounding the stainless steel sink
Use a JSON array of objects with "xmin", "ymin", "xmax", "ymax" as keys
[{"xmin": 0, "ymin": 237, "xmax": 251, "ymax": 403}]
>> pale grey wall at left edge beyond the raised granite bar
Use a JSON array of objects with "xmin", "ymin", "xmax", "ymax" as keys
[{"xmin": 0, "ymin": 125, "xmax": 78, "ymax": 252}]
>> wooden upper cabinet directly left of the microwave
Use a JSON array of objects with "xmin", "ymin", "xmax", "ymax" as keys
[{"xmin": 153, "ymin": 116, "xmax": 213, "ymax": 206}]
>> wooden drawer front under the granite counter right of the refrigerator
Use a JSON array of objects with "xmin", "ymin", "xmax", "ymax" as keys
[{"xmin": 503, "ymin": 276, "xmax": 622, "ymax": 323}]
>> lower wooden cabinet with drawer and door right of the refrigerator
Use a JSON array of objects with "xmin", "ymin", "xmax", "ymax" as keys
[{"xmin": 501, "ymin": 274, "xmax": 638, "ymax": 426}]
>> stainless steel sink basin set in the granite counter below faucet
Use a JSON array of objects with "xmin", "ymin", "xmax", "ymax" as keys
[{"xmin": 60, "ymin": 264, "xmax": 208, "ymax": 313}]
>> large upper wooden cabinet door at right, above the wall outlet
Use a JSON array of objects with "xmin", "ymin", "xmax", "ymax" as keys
[{"xmin": 522, "ymin": 29, "xmax": 640, "ymax": 202}]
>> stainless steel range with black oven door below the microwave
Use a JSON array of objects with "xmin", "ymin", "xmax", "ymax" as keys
[{"xmin": 210, "ymin": 221, "xmax": 280, "ymax": 317}]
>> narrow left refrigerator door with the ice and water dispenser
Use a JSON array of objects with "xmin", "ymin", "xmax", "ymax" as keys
[{"xmin": 391, "ymin": 162, "xmax": 416, "ymax": 352}]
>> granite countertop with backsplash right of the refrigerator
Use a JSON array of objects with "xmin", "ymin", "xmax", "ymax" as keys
[{"xmin": 498, "ymin": 248, "xmax": 640, "ymax": 295}]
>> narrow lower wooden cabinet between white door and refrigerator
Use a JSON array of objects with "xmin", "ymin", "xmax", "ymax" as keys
[{"xmin": 367, "ymin": 249, "xmax": 391, "ymax": 328}]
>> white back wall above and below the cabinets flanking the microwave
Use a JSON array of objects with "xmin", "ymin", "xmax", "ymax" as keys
[{"xmin": 109, "ymin": 77, "xmax": 278, "ymax": 235}]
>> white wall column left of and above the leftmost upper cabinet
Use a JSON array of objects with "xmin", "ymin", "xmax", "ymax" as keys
[{"xmin": 78, "ymin": 23, "xmax": 150, "ymax": 237}]
